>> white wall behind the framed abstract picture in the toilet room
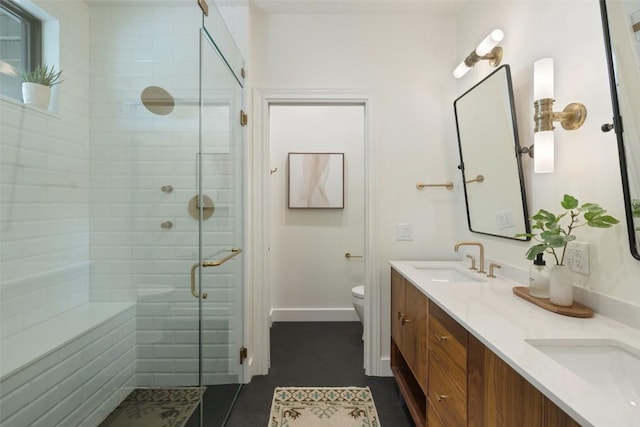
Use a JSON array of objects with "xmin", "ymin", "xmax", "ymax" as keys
[{"xmin": 269, "ymin": 105, "xmax": 365, "ymax": 321}]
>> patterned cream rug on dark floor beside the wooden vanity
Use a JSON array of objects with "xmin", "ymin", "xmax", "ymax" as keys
[{"xmin": 269, "ymin": 387, "xmax": 380, "ymax": 427}]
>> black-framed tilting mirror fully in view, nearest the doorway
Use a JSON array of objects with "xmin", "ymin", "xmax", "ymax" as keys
[{"xmin": 453, "ymin": 65, "xmax": 530, "ymax": 240}]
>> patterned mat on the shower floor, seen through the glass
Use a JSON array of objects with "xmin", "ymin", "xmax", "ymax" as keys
[{"xmin": 100, "ymin": 387, "xmax": 205, "ymax": 427}]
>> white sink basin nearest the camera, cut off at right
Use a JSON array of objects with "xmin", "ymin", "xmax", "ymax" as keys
[{"xmin": 526, "ymin": 339, "xmax": 640, "ymax": 412}]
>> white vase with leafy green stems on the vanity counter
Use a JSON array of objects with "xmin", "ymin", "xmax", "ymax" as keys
[{"xmin": 517, "ymin": 194, "xmax": 620, "ymax": 306}]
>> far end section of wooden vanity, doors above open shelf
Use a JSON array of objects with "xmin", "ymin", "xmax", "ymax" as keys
[{"xmin": 391, "ymin": 269, "xmax": 429, "ymax": 426}]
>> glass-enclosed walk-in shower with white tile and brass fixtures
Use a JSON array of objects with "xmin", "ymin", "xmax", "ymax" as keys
[{"xmin": 0, "ymin": 0, "xmax": 244, "ymax": 426}]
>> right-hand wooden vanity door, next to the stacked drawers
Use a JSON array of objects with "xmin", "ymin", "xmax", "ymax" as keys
[{"xmin": 400, "ymin": 283, "xmax": 429, "ymax": 391}]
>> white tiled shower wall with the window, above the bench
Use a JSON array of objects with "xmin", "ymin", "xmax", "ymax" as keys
[{"xmin": 0, "ymin": 0, "xmax": 89, "ymax": 342}]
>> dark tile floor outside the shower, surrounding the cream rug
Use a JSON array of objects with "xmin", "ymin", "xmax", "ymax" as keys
[{"xmin": 224, "ymin": 322, "xmax": 413, "ymax": 427}]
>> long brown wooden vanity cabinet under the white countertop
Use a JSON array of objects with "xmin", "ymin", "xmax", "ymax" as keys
[{"xmin": 391, "ymin": 268, "xmax": 579, "ymax": 427}]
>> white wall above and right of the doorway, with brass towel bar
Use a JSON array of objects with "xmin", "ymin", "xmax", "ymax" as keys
[{"xmin": 251, "ymin": 10, "xmax": 461, "ymax": 364}]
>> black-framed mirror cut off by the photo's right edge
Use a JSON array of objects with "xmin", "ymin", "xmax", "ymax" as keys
[{"xmin": 600, "ymin": 0, "xmax": 640, "ymax": 260}]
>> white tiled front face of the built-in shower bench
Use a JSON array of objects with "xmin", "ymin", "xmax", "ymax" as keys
[{"xmin": 0, "ymin": 303, "xmax": 136, "ymax": 427}]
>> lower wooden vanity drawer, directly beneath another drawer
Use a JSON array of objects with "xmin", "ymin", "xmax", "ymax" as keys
[{"xmin": 428, "ymin": 353, "xmax": 467, "ymax": 427}]
